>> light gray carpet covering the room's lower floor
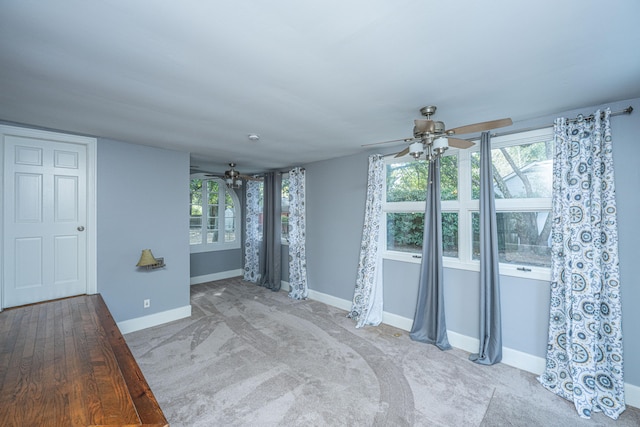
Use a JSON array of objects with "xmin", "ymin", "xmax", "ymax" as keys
[{"xmin": 125, "ymin": 278, "xmax": 640, "ymax": 427}]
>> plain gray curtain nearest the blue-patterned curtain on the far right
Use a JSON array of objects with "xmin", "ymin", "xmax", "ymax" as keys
[{"xmin": 469, "ymin": 132, "xmax": 502, "ymax": 365}]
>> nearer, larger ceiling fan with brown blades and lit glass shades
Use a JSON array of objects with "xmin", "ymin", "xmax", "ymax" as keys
[{"xmin": 363, "ymin": 105, "xmax": 513, "ymax": 161}]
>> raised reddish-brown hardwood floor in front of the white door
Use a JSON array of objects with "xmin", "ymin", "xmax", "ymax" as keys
[{"xmin": 0, "ymin": 295, "xmax": 168, "ymax": 426}]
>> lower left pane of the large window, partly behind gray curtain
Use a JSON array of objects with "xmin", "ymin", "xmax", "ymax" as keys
[{"xmin": 387, "ymin": 212, "xmax": 458, "ymax": 257}]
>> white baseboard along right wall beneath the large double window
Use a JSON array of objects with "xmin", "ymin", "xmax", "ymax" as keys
[{"xmin": 302, "ymin": 282, "xmax": 640, "ymax": 408}]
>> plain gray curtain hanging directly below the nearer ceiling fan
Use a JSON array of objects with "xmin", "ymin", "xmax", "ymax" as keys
[{"xmin": 409, "ymin": 158, "xmax": 451, "ymax": 350}]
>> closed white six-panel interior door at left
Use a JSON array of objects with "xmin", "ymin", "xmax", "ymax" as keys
[{"xmin": 3, "ymin": 135, "xmax": 87, "ymax": 307}]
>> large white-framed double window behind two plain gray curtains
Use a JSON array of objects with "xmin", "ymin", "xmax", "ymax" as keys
[{"xmin": 383, "ymin": 129, "xmax": 553, "ymax": 279}]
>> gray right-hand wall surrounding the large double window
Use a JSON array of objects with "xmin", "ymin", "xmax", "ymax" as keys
[{"xmin": 305, "ymin": 99, "xmax": 640, "ymax": 385}]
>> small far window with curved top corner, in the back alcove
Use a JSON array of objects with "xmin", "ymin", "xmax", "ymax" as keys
[{"xmin": 189, "ymin": 175, "xmax": 240, "ymax": 252}]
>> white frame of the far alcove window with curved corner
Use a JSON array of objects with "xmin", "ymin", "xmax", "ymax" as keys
[{"xmin": 189, "ymin": 173, "xmax": 242, "ymax": 254}]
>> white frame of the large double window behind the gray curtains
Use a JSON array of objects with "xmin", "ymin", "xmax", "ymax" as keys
[{"xmin": 381, "ymin": 128, "xmax": 553, "ymax": 280}]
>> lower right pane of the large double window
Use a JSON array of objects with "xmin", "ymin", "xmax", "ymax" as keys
[{"xmin": 472, "ymin": 211, "xmax": 551, "ymax": 267}]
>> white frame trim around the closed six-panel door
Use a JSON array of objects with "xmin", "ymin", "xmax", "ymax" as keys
[{"xmin": 0, "ymin": 125, "xmax": 98, "ymax": 311}]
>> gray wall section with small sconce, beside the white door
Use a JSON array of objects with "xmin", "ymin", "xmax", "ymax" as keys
[{"xmin": 97, "ymin": 139, "xmax": 190, "ymax": 322}]
